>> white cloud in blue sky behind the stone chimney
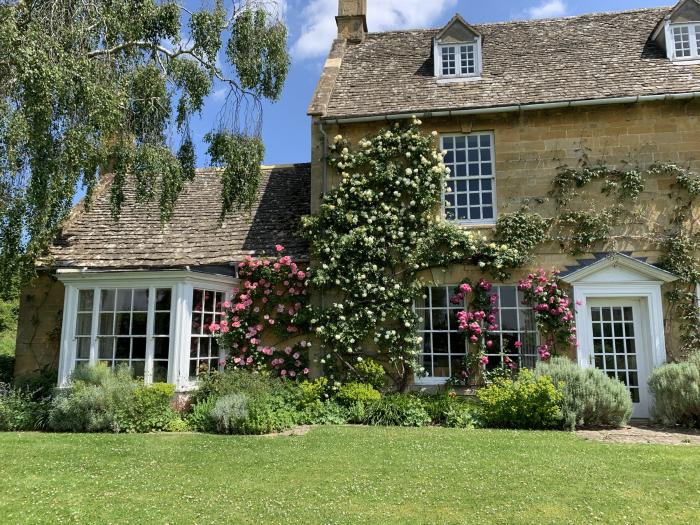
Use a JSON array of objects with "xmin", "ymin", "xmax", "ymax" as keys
[{"xmin": 292, "ymin": 0, "xmax": 457, "ymax": 59}]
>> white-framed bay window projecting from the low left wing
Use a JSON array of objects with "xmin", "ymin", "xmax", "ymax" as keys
[{"xmin": 58, "ymin": 271, "xmax": 236, "ymax": 390}]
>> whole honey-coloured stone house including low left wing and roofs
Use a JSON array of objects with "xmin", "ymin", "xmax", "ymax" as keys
[{"xmin": 17, "ymin": 0, "xmax": 700, "ymax": 417}]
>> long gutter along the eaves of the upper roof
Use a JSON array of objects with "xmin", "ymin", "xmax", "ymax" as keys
[{"xmin": 322, "ymin": 91, "xmax": 700, "ymax": 124}]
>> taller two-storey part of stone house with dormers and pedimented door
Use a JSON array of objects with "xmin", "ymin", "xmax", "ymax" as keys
[{"xmin": 308, "ymin": 0, "xmax": 700, "ymax": 417}]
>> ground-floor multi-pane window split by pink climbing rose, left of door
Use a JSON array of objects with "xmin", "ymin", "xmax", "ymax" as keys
[{"xmin": 416, "ymin": 285, "xmax": 538, "ymax": 383}]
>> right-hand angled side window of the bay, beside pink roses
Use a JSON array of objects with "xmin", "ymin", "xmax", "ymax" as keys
[{"xmin": 189, "ymin": 288, "xmax": 226, "ymax": 380}]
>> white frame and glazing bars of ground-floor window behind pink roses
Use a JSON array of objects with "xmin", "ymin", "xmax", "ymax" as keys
[{"xmin": 414, "ymin": 284, "xmax": 539, "ymax": 386}]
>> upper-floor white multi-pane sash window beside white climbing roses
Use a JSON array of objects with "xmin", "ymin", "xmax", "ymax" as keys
[{"xmin": 441, "ymin": 133, "xmax": 496, "ymax": 224}]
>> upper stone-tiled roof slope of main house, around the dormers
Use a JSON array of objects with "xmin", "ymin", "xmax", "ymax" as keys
[{"xmin": 324, "ymin": 8, "xmax": 700, "ymax": 118}]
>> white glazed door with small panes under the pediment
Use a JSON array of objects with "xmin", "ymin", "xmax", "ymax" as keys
[{"xmin": 581, "ymin": 298, "xmax": 651, "ymax": 418}]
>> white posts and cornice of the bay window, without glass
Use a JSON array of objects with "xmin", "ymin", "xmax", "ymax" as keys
[{"xmin": 57, "ymin": 270, "xmax": 238, "ymax": 391}]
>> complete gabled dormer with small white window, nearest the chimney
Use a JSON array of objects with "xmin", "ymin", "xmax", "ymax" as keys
[{"xmin": 434, "ymin": 15, "xmax": 481, "ymax": 81}]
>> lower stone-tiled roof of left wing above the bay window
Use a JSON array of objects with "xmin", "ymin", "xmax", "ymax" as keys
[{"xmin": 50, "ymin": 164, "xmax": 310, "ymax": 268}]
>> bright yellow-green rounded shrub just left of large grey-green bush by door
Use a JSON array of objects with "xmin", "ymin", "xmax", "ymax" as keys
[{"xmin": 477, "ymin": 369, "xmax": 563, "ymax": 429}]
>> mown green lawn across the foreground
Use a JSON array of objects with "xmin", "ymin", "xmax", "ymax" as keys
[{"xmin": 0, "ymin": 427, "xmax": 700, "ymax": 525}]
